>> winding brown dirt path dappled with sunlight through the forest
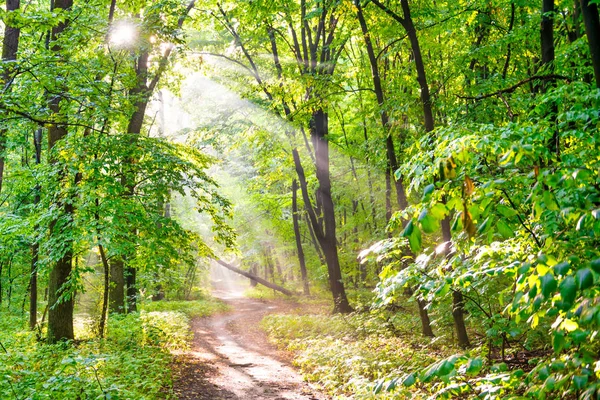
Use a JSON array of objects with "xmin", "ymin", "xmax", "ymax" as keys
[{"xmin": 174, "ymin": 291, "xmax": 327, "ymax": 400}]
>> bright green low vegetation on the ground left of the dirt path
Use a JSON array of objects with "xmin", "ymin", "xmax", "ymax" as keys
[{"xmin": 0, "ymin": 298, "xmax": 227, "ymax": 400}]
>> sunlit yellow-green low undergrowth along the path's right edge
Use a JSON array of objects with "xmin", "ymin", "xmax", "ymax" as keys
[{"xmin": 262, "ymin": 313, "xmax": 456, "ymax": 399}]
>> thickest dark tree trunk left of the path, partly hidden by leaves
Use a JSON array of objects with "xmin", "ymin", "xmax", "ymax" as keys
[{"xmin": 48, "ymin": 0, "xmax": 74, "ymax": 343}]
